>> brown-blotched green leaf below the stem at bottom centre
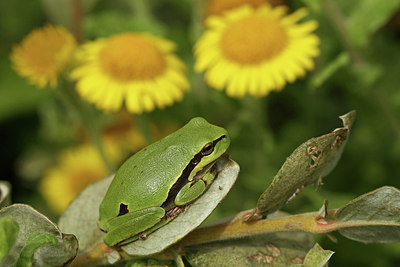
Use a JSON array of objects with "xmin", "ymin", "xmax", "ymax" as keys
[{"xmin": 185, "ymin": 232, "xmax": 314, "ymax": 267}]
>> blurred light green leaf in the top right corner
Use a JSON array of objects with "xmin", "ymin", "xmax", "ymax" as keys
[{"xmin": 347, "ymin": 0, "xmax": 400, "ymax": 46}]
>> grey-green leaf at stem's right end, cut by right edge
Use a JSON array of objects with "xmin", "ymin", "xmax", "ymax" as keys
[{"xmin": 336, "ymin": 186, "xmax": 400, "ymax": 243}]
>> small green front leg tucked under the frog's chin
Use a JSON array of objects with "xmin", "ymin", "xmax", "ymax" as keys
[{"xmin": 175, "ymin": 173, "xmax": 215, "ymax": 206}]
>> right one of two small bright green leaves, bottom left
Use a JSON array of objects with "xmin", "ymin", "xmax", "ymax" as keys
[{"xmin": 16, "ymin": 232, "xmax": 57, "ymax": 267}]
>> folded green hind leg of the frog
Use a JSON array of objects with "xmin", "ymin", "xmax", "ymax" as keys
[{"xmin": 104, "ymin": 207, "xmax": 165, "ymax": 246}]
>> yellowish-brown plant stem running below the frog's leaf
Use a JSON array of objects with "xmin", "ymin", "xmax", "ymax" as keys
[{"xmin": 71, "ymin": 209, "xmax": 381, "ymax": 266}]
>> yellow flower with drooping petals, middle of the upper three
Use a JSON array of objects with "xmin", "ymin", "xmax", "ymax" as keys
[{"xmin": 71, "ymin": 33, "xmax": 189, "ymax": 113}]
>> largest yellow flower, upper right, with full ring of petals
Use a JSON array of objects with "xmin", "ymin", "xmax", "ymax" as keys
[{"xmin": 194, "ymin": 5, "xmax": 319, "ymax": 97}]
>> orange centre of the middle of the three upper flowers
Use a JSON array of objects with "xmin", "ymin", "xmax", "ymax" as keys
[{"xmin": 100, "ymin": 33, "xmax": 166, "ymax": 82}]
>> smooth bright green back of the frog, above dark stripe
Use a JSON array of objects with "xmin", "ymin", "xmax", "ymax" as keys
[{"xmin": 100, "ymin": 118, "xmax": 225, "ymax": 221}]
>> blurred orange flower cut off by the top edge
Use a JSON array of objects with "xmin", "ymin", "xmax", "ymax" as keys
[{"xmin": 206, "ymin": 0, "xmax": 286, "ymax": 16}]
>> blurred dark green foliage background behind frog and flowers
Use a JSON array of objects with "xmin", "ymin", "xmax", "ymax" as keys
[{"xmin": 0, "ymin": 0, "xmax": 400, "ymax": 266}]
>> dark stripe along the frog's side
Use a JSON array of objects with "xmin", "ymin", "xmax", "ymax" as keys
[{"xmin": 161, "ymin": 135, "xmax": 226, "ymax": 209}]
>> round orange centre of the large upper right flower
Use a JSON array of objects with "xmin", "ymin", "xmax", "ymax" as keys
[{"xmin": 221, "ymin": 15, "xmax": 288, "ymax": 64}]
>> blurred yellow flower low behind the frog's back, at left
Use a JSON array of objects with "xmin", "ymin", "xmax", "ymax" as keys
[{"xmin": 39, "ymin": 144, "xmax": 118, "ymax": 214}]
